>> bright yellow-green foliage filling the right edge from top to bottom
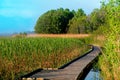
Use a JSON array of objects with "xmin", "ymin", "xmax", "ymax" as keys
[{"xmin": 100, "ymin": 0, "xmax": 120, "ymax": 80}]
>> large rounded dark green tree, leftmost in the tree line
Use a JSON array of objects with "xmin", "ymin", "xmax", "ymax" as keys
[{"xmin": 35, "ymin": 8, "xmax": 74, "ymax": 34}]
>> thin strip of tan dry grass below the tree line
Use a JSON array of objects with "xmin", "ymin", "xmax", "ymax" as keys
[{"xmin": 27, "ymin": 34, "xmax": 90, "ymax": 38}]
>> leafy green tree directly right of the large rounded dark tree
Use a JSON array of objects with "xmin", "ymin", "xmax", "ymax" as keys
[{"xmin": 68, "ymin": 9, "xmax": 86, "ymax": 34}]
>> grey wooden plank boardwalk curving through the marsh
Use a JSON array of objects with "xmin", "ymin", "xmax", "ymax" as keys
[{"xmin": 23, "ymin": 46, "xmax": 100, "ymax": 80}]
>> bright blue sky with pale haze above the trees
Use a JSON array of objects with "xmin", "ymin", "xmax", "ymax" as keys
[{"xmin": 0, "ymin": 0, "xmax": 102, "ymax": 33}]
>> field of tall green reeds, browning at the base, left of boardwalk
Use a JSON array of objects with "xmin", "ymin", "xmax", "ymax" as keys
[{"xmin": 0, "ymin": 38, "xmax": 90, "ymax": 80}]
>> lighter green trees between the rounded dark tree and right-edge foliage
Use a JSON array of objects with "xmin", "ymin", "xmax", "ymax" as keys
[{"xmin": 68, "ymin": 8, "xmax": 106, "ymax": 34}]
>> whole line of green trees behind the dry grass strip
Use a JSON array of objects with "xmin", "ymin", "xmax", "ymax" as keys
[{"xmin": 34, "ymin": 2, "xmax": 118, "ymax": 34}]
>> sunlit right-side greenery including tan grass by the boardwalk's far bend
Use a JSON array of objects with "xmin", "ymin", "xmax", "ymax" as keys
[{"xmin": 88, "ymin": 0, "xmax": 120, "ymax": 80}]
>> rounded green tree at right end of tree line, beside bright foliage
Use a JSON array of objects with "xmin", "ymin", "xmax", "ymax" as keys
[{"xmin": 87, "ymin": 8, "xmax": 106, "ymax": 32}]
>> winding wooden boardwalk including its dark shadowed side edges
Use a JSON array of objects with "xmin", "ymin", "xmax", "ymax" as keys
[{"xmin": 21, "ymin": 46, "xmax": 101, "ymax": 80}]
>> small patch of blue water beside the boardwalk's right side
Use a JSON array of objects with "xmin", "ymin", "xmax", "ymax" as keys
[{"xmin": 85, "ymin": 69, "xmax": 103, "ymax": 80}]
